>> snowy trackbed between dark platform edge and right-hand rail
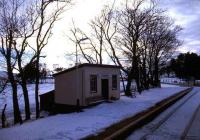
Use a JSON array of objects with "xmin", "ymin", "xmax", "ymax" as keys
[{"xmin": 127, "ymin": 88, "xmax": 200, "ymax": 140}]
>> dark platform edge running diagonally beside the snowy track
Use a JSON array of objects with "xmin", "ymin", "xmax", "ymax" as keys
[{"xmin": 83, "ymin": 88, "xmax": 192, "ymax": 140}]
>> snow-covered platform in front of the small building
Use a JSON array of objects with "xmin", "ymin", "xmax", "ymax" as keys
[{"xmin": 0, "ymin": 87, "xmax": 188, "ymax": 140}]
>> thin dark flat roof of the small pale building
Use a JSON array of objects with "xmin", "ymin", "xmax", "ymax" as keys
[{"xmin": 53, "ymin": 63, "xmax": 120, "ymax": 76}]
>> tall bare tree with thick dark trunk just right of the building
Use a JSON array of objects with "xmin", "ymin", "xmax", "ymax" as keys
[{"xmin": 107, "ymin": 0, "xmax": 157, "ymax": 96}]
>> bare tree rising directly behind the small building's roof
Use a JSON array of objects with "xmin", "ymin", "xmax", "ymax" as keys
[{"xmin": 70, "ymin": 4, "xmax": 114, "ymax": 64}]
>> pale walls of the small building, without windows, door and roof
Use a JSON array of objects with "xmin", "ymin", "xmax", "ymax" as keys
[{"xmin": 55, "ymin": 67, "xmax": 120, "ymax": 106}]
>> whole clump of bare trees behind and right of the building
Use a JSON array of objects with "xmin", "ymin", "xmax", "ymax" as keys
[{"xmin": 68, "ymin": 0, "xmax": 180, "ymax": 96}]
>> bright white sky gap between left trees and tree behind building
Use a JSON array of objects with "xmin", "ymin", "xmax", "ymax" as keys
[{"xmin": 43, "ymin": 0, "xmax": 111, "ymax": 69}]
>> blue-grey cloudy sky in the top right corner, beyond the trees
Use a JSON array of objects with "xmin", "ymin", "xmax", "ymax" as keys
[{"xmin": 159, "ymin": 0, "xmax": 200, "ymax": 52}]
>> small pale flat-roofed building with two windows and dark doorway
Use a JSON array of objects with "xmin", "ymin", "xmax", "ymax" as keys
[{"xmin": 54, "ymin": 64, "xmax": 120, "ymax": 106}]
